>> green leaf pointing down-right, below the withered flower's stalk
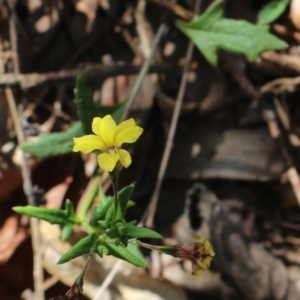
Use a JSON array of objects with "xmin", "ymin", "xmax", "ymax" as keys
[{"xmin": 101, "ymin": 243, "xmax": 147, "ymax": 269}]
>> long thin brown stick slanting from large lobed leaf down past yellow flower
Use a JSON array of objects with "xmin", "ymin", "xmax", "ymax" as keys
[{"xmin": 142, "ymin": 0, "xmax": 200, "ymax": 228}]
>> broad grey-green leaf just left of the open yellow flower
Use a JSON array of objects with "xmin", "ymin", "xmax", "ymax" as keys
[{"xmin": 19, "ymin": 122, "xmax": 83, "ymax": 159}]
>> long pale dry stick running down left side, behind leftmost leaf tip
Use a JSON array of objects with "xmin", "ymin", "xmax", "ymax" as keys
[{"xmin": 5, "ymin": 87, "xmax": 44, "ymax": 300}]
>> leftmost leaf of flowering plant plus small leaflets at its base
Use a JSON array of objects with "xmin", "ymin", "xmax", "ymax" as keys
[{"xmin": 13, "ymin": 200, "xmax": 81, "ymax": 240}]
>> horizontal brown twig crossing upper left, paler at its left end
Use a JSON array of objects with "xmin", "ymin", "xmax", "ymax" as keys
[{"xmin": 0, "ymin": 64, "xmax": 174, "ymax": 89}]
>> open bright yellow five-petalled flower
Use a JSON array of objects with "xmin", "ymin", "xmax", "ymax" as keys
[{"xmin": 73, "ymin": 115, "xmax": 143, "ymax": 172}]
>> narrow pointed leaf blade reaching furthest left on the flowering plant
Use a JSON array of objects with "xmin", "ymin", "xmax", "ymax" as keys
[{"xmin": 13, "ymin": 205, "xmax": 68, "ymax": 225}]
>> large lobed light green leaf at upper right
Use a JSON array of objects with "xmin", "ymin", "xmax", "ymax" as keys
[{"xmin": 176, "ymin": 0, "xmax": 287, "ymax": 65}]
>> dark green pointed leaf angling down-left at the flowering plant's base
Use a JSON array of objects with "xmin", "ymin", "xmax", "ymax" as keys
[{"xmin": 57, "ymin": 233, "xmax": 99, "ymax": 264}]
